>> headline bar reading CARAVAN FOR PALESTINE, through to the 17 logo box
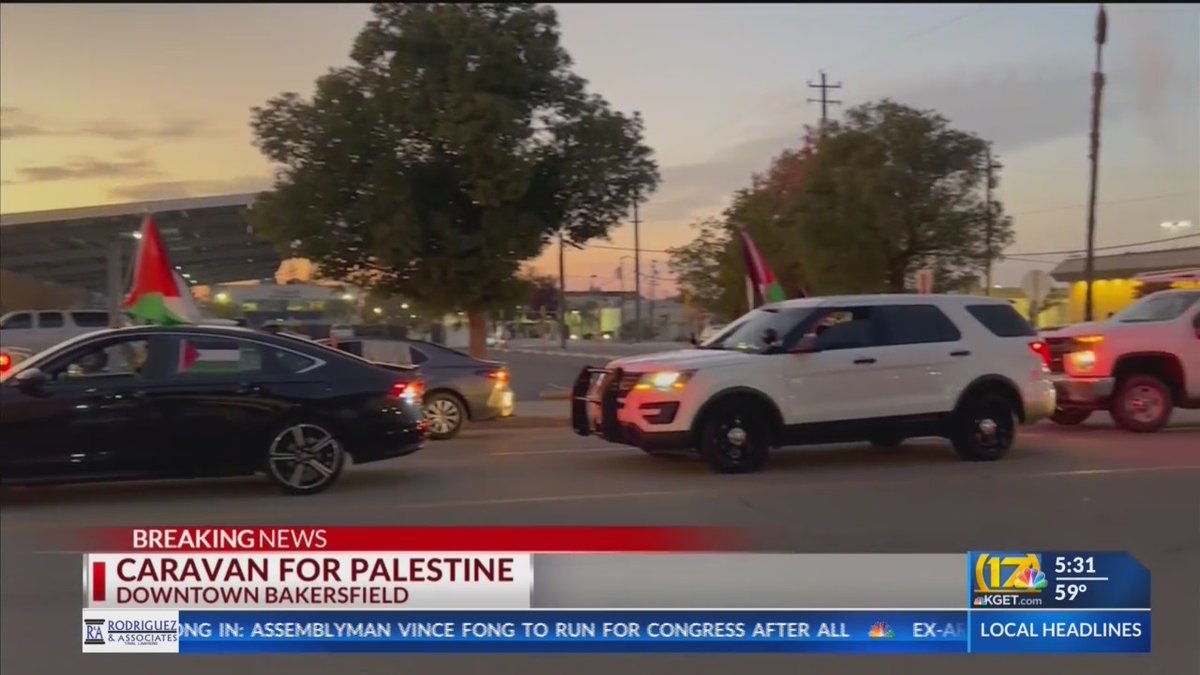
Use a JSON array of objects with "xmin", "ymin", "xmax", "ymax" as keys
[{"xmin": 83, "ymin": 551, "xmax": 1150, "ymax": 610}]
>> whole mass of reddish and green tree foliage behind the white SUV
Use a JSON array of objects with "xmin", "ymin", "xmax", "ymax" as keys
[{"xmin": 671, "ymin": 100, "xmax": 1013, "ymax": 305}]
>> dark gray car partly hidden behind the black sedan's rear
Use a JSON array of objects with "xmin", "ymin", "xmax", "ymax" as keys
[{"xmin": 319, "ymin": 338, "xmax": 514, "ymax": 440}]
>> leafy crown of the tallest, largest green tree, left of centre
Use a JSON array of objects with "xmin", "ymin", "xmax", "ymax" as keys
[{"xmin": 243, "ymin": 4, "xmax": 659, "ymax": 312}]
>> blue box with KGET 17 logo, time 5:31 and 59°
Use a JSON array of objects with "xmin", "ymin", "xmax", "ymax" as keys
[{"xmin": 967, "ymin": 551, "xmax": 1150, "ymax": 610}]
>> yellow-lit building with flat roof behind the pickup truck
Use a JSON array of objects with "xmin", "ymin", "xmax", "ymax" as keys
[{"xmin": 1050, "ymin": 246, "xmax": 1200, "ymax": 323}]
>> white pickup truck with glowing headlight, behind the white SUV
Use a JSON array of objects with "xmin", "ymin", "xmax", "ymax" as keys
[{"xmin": 1042, "ymin": 289, "xmax": 1200, "ymax": 432}]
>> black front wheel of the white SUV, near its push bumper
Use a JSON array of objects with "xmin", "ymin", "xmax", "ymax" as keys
[{"xmin": 700, "ymin": 400, "xmax": 770, "ymax": 473}]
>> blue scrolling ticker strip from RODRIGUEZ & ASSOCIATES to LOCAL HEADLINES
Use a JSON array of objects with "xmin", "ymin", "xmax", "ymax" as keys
[{"xmin": 83, "ymin": 609, "xmax": 1151, "ymax": 655}]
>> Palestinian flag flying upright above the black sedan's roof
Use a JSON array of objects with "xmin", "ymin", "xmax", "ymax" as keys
[{"xmin": 124, "ymin": 215, "xmax": 200, "ymax": 325}]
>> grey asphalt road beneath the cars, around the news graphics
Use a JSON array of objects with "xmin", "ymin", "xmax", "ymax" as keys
[{"xmin": 0, "ymin": 417, "xmax": 1200, "ymax": 675}]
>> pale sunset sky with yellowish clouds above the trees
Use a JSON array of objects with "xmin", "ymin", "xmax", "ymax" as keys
[{"xmin": 0, "ymin": 4, "xmax": 1200, "ymax": 289}]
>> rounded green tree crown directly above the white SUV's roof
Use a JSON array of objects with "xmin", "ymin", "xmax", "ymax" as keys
[{"xmin": 784, "ymin": 100, "xmax": 1013, "ymax": 293}]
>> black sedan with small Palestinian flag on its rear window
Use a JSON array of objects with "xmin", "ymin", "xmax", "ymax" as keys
[{"xmin": 0, "ymin": 325, "xmax": 428, "ymax": 495}]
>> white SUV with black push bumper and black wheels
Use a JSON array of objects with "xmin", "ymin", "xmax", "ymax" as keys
[{"xmin": 571, "ymin": 295, "xmax": 1055, "ymax": 473}]
